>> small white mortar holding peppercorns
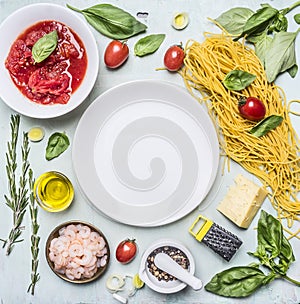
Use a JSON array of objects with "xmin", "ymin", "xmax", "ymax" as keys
[{"xmin": 139, "ymin": 239, "xmax": 195, "ymax": 294}]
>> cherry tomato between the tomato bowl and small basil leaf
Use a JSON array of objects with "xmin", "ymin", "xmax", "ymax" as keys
[{"xmin": 104, "ymin": 40, "xmax": 129, "ymax": 69}]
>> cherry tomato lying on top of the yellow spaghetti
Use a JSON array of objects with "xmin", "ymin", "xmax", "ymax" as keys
[{"xmin": 238, "ymin": 97, "xmax": 266, "ymax": 121}]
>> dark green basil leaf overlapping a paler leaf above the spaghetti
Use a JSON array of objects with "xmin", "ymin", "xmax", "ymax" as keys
[{"xmin": 235, "ymin": 6, "xmax": 279, "ymax": 40}]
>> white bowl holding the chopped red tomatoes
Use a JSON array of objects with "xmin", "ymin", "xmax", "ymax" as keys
[{"xmin": 0, "ymin": 3, "xmax": 99, "ymax": 118}]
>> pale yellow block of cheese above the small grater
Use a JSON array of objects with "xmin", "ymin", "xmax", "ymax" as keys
[{"xmin": 217, "ymin": 174, "xmax": 268, "ymax": 228}]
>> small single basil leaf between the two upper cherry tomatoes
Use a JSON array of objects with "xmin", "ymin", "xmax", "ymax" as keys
[{"xmin": 134, "ymin": 34, "xmax": 166, "ymax": 57}]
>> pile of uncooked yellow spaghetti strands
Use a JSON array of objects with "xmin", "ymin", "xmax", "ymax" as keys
[{"xmin": 181, "ymin": 33, "xmax": 300, "ymax": 238}]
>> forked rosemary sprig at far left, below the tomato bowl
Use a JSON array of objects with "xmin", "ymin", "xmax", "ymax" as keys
[{"xmin": 1, "ymin": 115, "xmax": 30, "ymax": 255}]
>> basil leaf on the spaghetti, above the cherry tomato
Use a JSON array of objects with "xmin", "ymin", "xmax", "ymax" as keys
[{"xmin": 223, "ymin": 70, "xmax": 256, "ymax": 91}]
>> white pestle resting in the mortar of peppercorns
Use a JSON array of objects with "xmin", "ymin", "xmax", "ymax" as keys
[{"xmin": 154, "ymin": 253, "xmax": 203, "ymax": 290}]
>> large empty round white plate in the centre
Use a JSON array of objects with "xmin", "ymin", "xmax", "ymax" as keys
[{"xmin": 73, "ymin": 80, "xmax": 219, "ymax": 226}]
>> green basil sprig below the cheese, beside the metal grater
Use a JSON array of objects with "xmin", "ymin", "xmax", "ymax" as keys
[{"xmin": 204, "ymin": 210, "xmax": 300, "ymax": 298}]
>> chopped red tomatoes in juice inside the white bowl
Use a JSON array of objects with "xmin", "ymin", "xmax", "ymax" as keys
[{"xmin": 5, "ymin": 20, "xmax": 87, "ymax": 104}]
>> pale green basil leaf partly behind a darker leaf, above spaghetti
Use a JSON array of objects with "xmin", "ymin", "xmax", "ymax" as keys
[{"xmin": 215, "ymin": 7, "xmax": 254, "ymax": 35}]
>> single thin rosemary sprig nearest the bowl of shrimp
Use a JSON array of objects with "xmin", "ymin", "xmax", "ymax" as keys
[{"xmin": 27, "ymin": 169, "xmax": 40, "ymax": 295}]
